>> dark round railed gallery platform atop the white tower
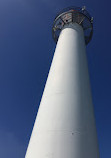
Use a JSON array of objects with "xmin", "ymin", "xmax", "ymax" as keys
[{"xmin": 52, "ymin": 7, "xmax": 93, "ymax": 44}]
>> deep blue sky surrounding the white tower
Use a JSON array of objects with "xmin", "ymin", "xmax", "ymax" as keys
[{"xmin": 0, "ymin": 0, "xmax": 111, "ymax": 158}]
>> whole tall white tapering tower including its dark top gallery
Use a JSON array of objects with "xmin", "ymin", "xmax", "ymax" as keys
[{"xmin": 25, "ymin": 7, "xmax": 99, "ymax": 158}]
